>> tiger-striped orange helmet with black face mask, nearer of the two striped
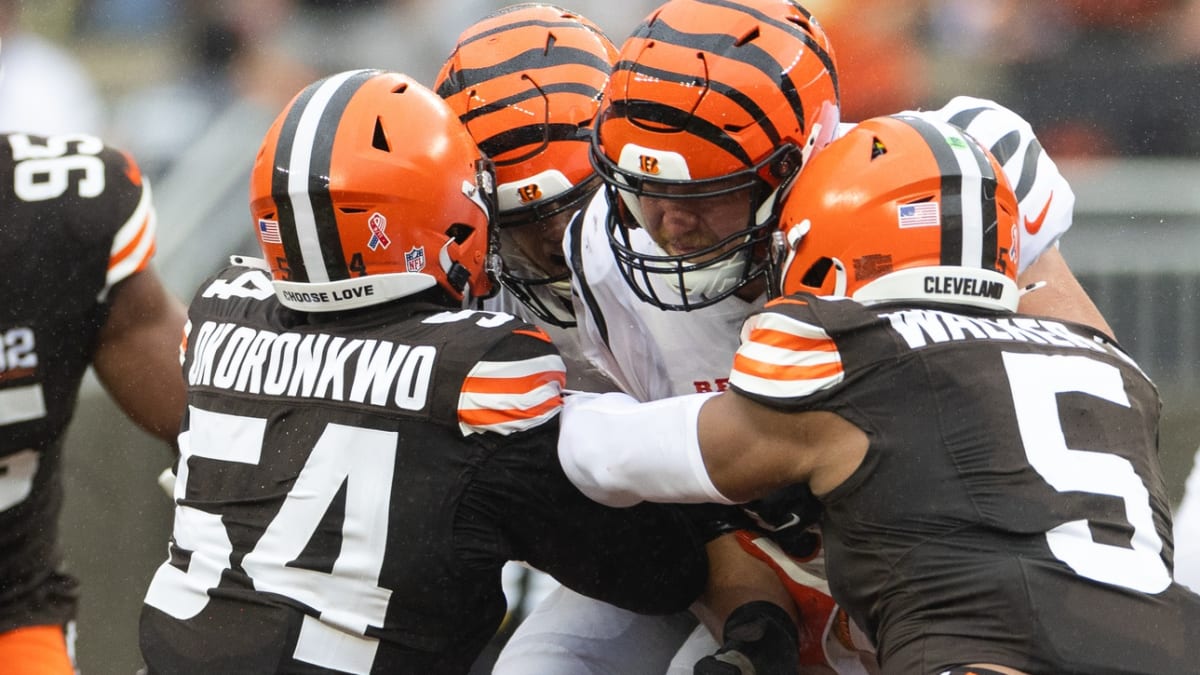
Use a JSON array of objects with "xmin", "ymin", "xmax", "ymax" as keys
[{"xmin": 592, "ymin": 0, "xmax": 839, "ymax": 310}]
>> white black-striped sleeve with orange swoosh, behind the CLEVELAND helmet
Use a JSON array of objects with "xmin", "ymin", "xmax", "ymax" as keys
[{"xmin": 914, "ymin": 96, "xmax": 1075, "ymax": 271}]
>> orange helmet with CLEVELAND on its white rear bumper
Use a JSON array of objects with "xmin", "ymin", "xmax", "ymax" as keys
[{"xmin": 778, "ymin": 114, "xmax": 1020, "ymax": 311}]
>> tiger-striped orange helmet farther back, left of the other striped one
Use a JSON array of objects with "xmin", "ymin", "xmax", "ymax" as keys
[{"xmin": 434, "ymin": 2, "xmax": 617, "ymax": 325}]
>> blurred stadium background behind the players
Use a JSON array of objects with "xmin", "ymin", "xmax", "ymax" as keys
[{"xmin": 0, "ymin": 0, "xmax": 1200, "ymax": 675}]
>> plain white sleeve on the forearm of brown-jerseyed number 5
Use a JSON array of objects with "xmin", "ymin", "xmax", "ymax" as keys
[{"xmin": 558, "ymin": 393, "xmax": 734, "ymax": 507}]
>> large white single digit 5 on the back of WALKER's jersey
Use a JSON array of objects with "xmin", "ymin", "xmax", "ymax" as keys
[{"xmin": 1004, "ymin": 352, "xmax": 1171, "ymax": 593}]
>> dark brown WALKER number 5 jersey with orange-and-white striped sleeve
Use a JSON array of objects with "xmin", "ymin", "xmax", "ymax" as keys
[{"xmin": 731, "ymin": 295, "xmax": 1200, "ymax": 675}]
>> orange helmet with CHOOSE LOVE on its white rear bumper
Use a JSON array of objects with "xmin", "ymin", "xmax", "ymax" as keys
[{"xmin": 250, "ymin": 70, "xmax": 499, "ymax": 311}]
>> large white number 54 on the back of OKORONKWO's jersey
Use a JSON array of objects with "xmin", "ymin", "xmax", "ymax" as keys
[{"xmin": 145, "ymin": 407, "xmax": 397, "ymax": 673}]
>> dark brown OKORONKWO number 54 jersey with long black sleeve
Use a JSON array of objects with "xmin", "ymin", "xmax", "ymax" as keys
[{"xmin": 140, "ymin": 267, "xmax": 707, "ymax": 674}]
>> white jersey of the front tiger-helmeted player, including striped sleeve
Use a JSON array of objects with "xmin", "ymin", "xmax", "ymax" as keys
[{"xmin": 563, "ymin": 96, "xmax": 1075, "ymax": 401}]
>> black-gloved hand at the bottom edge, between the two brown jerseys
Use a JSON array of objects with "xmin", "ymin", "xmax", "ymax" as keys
[{"xmin": 692, "ymin": 601, "xmax": 799, "ymax": 675}]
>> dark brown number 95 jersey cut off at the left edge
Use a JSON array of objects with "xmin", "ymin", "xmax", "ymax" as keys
[{"xmin": 0, "ymin": 133, "xmax": 155, "ymax": 631}]
